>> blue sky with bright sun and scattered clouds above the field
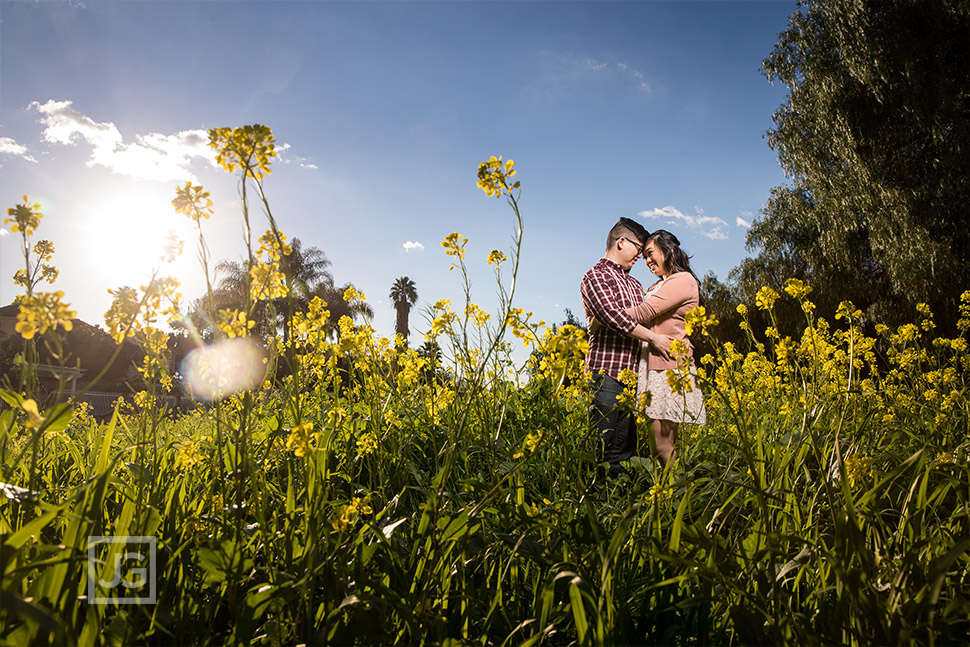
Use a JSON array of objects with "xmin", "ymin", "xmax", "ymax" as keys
[{"xmin": 0, "ymin": 0, "xmax": 795, "ymax": 364}]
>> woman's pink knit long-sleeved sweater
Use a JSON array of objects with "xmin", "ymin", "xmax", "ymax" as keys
[{"xmin": 628, "ymin": 272, "xmax": 700, "ymax": 371}]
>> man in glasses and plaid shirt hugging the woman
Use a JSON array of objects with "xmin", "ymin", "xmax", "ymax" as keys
[{"xmin": 580, "ymin": 218, "xmax": 654, "ymax": 477}]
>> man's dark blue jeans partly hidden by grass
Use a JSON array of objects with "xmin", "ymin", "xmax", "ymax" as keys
[{"xmin": 589, "ymin": 373, "xmax": 637, "ymax": 478}]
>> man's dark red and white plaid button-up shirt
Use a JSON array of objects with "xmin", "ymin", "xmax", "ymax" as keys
[{"xmin": 579, "ymin": 258, "xmax": 643, "ymax": 378}]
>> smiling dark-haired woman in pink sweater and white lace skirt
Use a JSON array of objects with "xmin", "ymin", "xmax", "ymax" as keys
[{"xmin": 628, "ymin": 229, "xmax": 707, "ymax": 465}]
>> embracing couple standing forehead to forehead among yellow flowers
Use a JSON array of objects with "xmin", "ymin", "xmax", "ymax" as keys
[{"xmin": 580, "ymin": 218, "xmax": 707, "ymax": 477}]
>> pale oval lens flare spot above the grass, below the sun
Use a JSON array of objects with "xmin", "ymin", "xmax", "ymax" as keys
[{"xmin": 180, "ymin": 337, "xmax": 266, "ymax": 401}]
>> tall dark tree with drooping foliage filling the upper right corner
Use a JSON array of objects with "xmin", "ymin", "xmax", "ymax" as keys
[{"xmin": 729, "ymin": 0, "xmax": 970, "ymax": 332}]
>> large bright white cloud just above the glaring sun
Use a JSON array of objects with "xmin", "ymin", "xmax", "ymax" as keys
[{"xmin": 31, "ymin": 100, "xmax": 215, "ymax": 182}]
